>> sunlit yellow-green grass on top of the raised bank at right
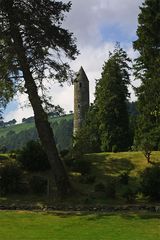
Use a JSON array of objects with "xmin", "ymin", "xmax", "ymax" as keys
[{"xmin": 86, "ymin": 151, "xmax": 160, "ymax": 176}]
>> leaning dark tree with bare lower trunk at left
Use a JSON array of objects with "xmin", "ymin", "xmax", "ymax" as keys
[{"xmin": 0, "ymin": 0, "xmax": 77, "ymax": 194}]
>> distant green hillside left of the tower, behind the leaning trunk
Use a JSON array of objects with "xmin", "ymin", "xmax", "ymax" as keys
[{"xmin": 0, "ymin": 114, "xmax": 73, "ymax": 150}]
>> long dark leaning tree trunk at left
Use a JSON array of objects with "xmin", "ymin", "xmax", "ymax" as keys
[{"xmin": 9, "ymin": 15, "xmax": 71, "ymax": 196}]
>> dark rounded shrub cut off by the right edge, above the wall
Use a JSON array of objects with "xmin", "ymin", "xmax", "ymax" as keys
[{"xmin": 141, "ymin": 165, "xmax": 160, "ymax": 200}]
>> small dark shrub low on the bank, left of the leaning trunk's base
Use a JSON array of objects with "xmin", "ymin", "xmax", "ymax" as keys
[{"xmin": 29, "ymin": 176, "xmax": 47, "ymax": 194}]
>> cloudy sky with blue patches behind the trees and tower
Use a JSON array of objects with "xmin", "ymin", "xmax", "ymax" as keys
[{"xmin": 4, "ymin": 0, "xmax": 143, "ymax": 122}]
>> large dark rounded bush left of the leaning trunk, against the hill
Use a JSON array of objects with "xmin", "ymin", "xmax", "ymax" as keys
[{"xmin": 18, "ymin": 141, "xmax": 50, "ymax": 171}]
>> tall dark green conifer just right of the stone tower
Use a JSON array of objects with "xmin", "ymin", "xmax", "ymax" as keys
[{"xmin": 94, "ymin": 44, "xmax": 130, "ymax": 151}]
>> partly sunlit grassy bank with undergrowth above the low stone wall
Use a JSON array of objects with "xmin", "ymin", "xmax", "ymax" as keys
[{"xmin": 0, "ymin": 152, "xmax": 160, "ymax": 206}]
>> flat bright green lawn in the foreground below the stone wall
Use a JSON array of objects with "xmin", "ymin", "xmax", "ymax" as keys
[{"xmin": 0, "ymin": 211, "xmax": 160, "ymax": 240}]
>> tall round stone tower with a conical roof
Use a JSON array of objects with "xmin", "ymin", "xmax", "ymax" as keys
[{"xmin": 74, "ymin": 67, "xmax": 89, "ymax": 135}]
